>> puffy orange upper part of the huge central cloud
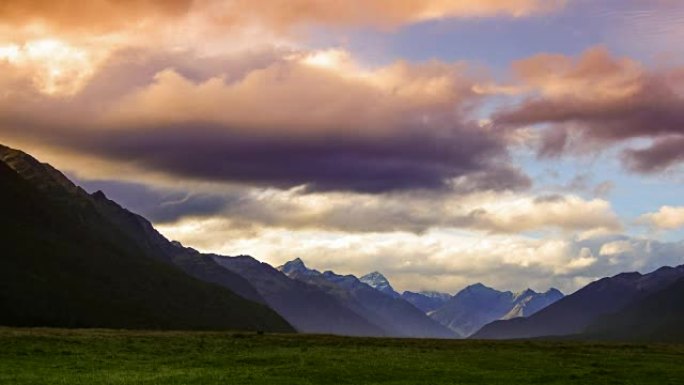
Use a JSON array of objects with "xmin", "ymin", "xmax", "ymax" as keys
[{"xmin": 109, "ymin": 50, "xmax": 479, "ymax": 135}]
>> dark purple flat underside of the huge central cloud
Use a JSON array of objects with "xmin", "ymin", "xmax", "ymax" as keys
[{"xmin": 55, "ymin": 124, "xmax": 530, "ymax": 193}]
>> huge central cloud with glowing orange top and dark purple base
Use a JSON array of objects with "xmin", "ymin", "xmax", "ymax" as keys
[{"xmin": 0, "ymin": 50, "xmax": 530, "ymax": 193}]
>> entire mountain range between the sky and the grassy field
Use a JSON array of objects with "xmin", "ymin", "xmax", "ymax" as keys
[{"xmin": 0, "ymin": 142, "xmax": 684, "ymax": 341}]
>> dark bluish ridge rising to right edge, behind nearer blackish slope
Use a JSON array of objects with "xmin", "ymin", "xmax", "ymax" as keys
[{"xmin": 473, "ymin": 266, "xmax": 684, "ymax": 339}]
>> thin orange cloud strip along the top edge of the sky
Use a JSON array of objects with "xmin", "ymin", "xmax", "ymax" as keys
[{"xmin": 0, "ymin": 0, "xmax": 566, "ymax": 32}]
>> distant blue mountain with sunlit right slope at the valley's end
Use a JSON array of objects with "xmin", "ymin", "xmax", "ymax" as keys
[{"xmin": 430, "ymin": 283, "xmax": 563, "ymax": 337}]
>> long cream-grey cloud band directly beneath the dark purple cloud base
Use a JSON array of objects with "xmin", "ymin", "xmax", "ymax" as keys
[{"xmin": 81, "ymin": 170, "xmax": 621, "ymax": 234}]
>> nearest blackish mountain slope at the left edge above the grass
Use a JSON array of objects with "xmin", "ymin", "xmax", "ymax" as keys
[{"xmin": 0, "ymin": 146, "xmax": 293, "ymax": 332}]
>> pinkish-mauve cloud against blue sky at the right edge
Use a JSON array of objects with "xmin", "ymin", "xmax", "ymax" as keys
[{"xmin": 493, "ymin": 47, "xmax": 684, "ymax": 173}]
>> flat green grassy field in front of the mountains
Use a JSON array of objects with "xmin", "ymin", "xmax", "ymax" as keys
[{"xmin": 0, "ymin": 328, "xmax": 684, "ymax": 385}]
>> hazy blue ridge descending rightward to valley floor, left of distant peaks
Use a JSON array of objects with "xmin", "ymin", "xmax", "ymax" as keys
[{"xmin": 278, "ymin": 259, "xmax": 456, "ymax": 338}]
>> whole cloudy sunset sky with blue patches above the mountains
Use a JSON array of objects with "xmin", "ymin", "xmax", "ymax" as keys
[{"xmin": 0, "ymin": 0, "xmax": 684, "ymax": 293}]
